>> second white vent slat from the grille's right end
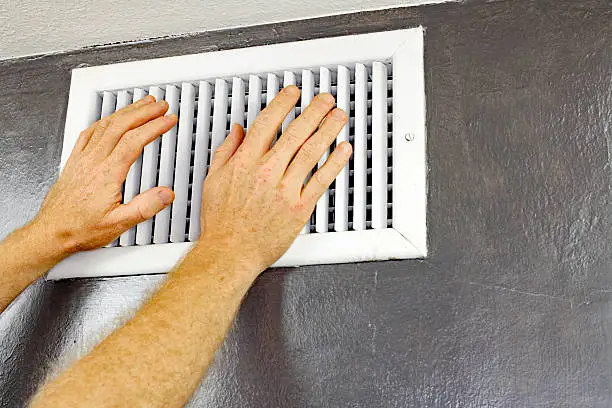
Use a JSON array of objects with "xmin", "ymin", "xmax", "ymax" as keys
[{"xmin": 352, "ymin": 64, "xmax": 368, "ymax": 231}]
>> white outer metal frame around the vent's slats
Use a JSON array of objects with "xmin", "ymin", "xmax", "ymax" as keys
[{"xmin": 47, "ymin": 27, "xmax": 427, "ymax": 279}]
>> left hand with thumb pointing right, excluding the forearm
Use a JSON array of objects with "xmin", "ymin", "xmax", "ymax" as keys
[{"xmin": 32, "ymin": 96, "xmax": 177, "ymax": 256}]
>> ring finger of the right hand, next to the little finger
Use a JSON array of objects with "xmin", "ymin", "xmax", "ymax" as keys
[{"xmin": 284, "ymin": 108, "xmax": 346, "ymax": 188}]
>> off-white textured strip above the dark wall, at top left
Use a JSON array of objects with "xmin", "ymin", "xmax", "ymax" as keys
[{"xmin": 0, "ymin": 0, "xmax": 449, "ymax": 59}]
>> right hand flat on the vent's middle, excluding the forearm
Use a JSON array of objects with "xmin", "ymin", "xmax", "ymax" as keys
[{"xmin": 196, "ymin": 86, "xmax": 352, "ymax": 273}]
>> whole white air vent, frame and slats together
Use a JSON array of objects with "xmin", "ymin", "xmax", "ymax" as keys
[{"xmin": 48, "ymin": 28, "xmax": 427, "ymax": 279}]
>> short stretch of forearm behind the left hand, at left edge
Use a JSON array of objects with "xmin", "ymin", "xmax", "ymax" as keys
[{"xmin": 0, "ymin": 220, "xmax": 66, "ymax": 312}]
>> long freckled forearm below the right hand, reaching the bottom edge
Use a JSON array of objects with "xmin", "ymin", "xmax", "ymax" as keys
[{"xmin": 33, "ymin": 243, "xmax": 260, "ymax": 407}]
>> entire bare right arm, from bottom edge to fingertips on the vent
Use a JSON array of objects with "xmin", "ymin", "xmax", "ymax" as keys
[{"xmin": 33, "ymin": 87, "xmax": 351, "ymax": 407}]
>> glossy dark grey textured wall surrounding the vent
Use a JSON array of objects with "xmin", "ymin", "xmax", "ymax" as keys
[{"xmin": 0, "ymin": 0, "xmax": 612, "ymax": 408}]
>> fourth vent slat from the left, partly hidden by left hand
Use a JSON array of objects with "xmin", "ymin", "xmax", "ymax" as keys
[{"xmin": 136, "ymin": 86, "xmax": 164, "ymax": 245}]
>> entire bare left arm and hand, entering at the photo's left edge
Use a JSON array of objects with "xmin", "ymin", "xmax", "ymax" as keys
[{"xmin": 0, "ymin": 96, "xmax": 177, "ymax": 312}]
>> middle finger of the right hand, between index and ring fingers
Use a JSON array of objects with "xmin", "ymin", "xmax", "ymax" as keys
[{"xmin": 264, "ymin": 93, "xmax": 335, "ymax": 175}]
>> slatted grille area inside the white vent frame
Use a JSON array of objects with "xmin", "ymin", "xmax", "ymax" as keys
[{"xmin": 98, "ymin": 61, "xmax": 393, "ymax": 246}]
